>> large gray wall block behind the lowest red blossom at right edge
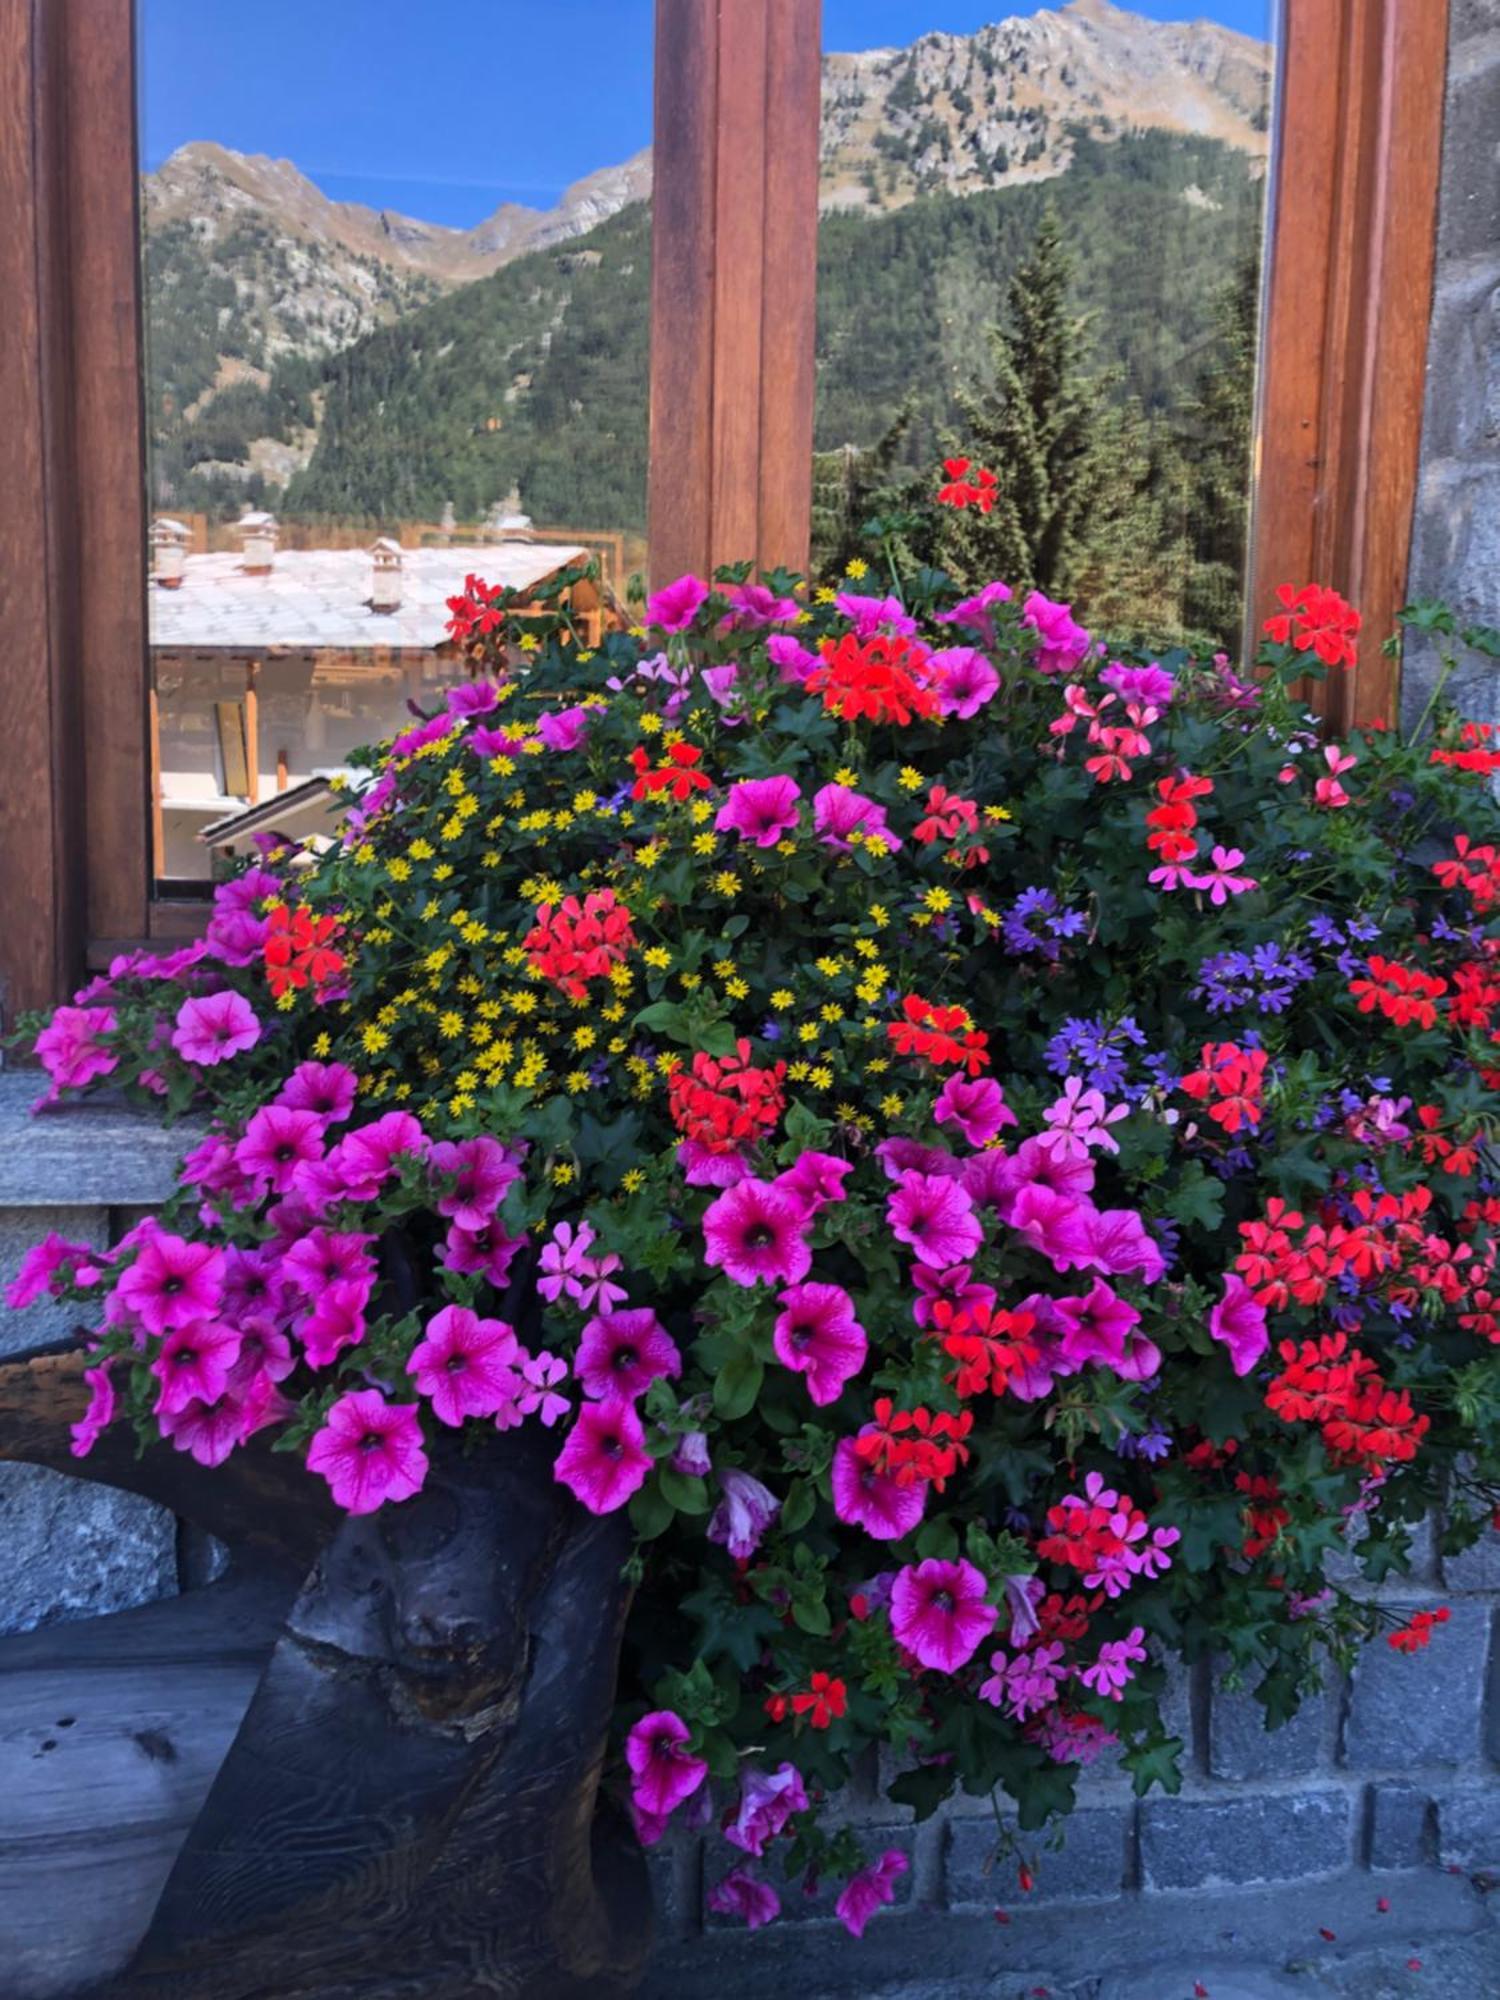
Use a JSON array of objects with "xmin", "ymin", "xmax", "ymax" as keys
[{"xmin": 1342, "ymin": 1602, "xmax": 1490, "ymax": 1772}]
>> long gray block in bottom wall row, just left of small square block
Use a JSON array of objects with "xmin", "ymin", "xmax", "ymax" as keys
[{"xmin": 1140, "ymin": 1792, "xmax": 1354, "ymax": 1890}]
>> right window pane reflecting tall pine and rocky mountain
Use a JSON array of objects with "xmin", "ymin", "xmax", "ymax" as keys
[{"xmin": 814, "ymin": 0, "xmax": 1272, "ymax": 650}]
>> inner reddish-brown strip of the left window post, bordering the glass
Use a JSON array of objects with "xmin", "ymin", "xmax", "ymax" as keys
[{"xmin": 54, "ymin": 0, "xmax": 152, "ymax": 936}]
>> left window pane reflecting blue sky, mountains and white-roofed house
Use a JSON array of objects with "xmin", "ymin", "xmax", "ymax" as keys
[{"xmin": 140, "ymin": 0, "xmax": 652, "ymax": 880}]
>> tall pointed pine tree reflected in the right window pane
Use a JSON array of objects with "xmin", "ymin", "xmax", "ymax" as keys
[{"xmin": 940, "ymin": 208, "xmax": 1164, "ymax": 630}]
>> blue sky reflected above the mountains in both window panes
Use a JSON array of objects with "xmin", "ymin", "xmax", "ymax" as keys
[{"xmin": 140, "ymin": 0, "xmax": 1270, "ymax": 226}]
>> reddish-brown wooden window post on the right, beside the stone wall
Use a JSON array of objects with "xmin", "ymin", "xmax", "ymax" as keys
[{"xmin": 1250, "ymin": 0, "xmax": 1448, "ymax": 728}]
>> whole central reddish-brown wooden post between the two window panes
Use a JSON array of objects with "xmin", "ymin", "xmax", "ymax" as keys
[{"xmin": 650, "ymin": 0, "xmax": 822, "ymax": 582}]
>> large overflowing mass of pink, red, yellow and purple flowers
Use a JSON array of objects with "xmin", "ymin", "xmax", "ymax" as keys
[{"xmin": 10, "ymin": 532, "xmax": 1500, "ymax": 1936}]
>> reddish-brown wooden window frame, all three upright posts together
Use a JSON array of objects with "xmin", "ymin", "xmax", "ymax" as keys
[{"xmin": 0, "ymin": 0, "xmax": 1446, "ymax": 1018}]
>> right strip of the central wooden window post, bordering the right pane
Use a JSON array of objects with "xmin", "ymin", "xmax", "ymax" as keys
[{"xmin": 756, "ymin": 0, "xmax": 822, "ymax": 572}]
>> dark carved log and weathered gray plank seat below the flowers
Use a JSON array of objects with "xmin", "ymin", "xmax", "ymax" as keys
[{"xmin": 0, "ymin": 1350, "xmax": 650, "ymax": 2000}]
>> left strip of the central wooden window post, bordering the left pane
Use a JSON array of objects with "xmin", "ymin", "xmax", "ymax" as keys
[{"xmin": 648, "ymin": 0, "xmax": 718, "ymax": 584}]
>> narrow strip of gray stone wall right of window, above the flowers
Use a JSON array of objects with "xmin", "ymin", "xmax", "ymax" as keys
[{"xmin": 1402, "ymin": 0, "xmax": 1500, "ymax": 722}]
